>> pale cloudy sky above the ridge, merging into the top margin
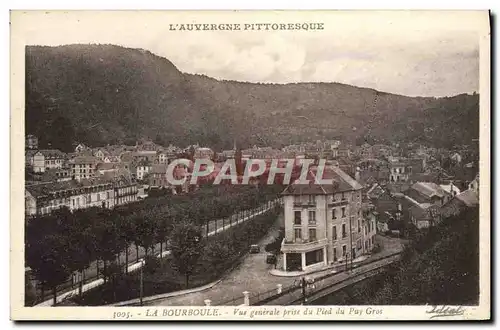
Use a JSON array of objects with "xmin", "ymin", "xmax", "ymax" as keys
[{"xmin": 11, "ymin": 11, "xmax": 487, "ymax": 97}]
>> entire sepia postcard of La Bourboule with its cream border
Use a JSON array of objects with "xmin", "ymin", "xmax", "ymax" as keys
[{"xmin": 10, "ymin": 10, "xmax": 490, "ymax": 321}]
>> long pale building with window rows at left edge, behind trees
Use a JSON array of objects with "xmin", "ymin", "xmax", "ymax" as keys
[{"xmin": 25, "ymin": 178, "xmax": 114, "ymax": 217}]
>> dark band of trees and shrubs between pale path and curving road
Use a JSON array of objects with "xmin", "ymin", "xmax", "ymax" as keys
[{"xmin": 72, "ymin": 208, "xmax": 281, "ymax": 306}]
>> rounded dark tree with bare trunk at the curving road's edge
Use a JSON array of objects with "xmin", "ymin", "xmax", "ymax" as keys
[{"xmin": 170, "ymin": 219, "xmax": 205, "ymax": 288}]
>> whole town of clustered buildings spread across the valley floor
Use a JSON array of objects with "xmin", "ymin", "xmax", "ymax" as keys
[{"xmin": 25, "ymin": 131, "xmax": 479, "ymax": 304}]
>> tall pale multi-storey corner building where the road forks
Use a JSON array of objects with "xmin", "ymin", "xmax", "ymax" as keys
[{"xmin": 281, "ymin": 166, "xmax": 366, "ymax": 271}]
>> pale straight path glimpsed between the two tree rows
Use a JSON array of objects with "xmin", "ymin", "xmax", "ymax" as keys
[{"xmin": 35, "ymin": 199, "xmax": 279, "ymax": 307}]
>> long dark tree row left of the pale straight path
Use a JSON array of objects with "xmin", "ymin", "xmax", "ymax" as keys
[{"xmin": 25, "ymin": 186, "xmax": 284, "ymax": 299}]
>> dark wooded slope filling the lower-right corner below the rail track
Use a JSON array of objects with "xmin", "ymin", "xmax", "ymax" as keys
[{"xmin": 314, "ymin": 208, "xmax": 479, "ymax": 305}]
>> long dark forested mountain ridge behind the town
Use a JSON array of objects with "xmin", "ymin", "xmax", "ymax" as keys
[{"xmin": 26, "ymin": 45, "xmax": 479, "ymax": 151}]
